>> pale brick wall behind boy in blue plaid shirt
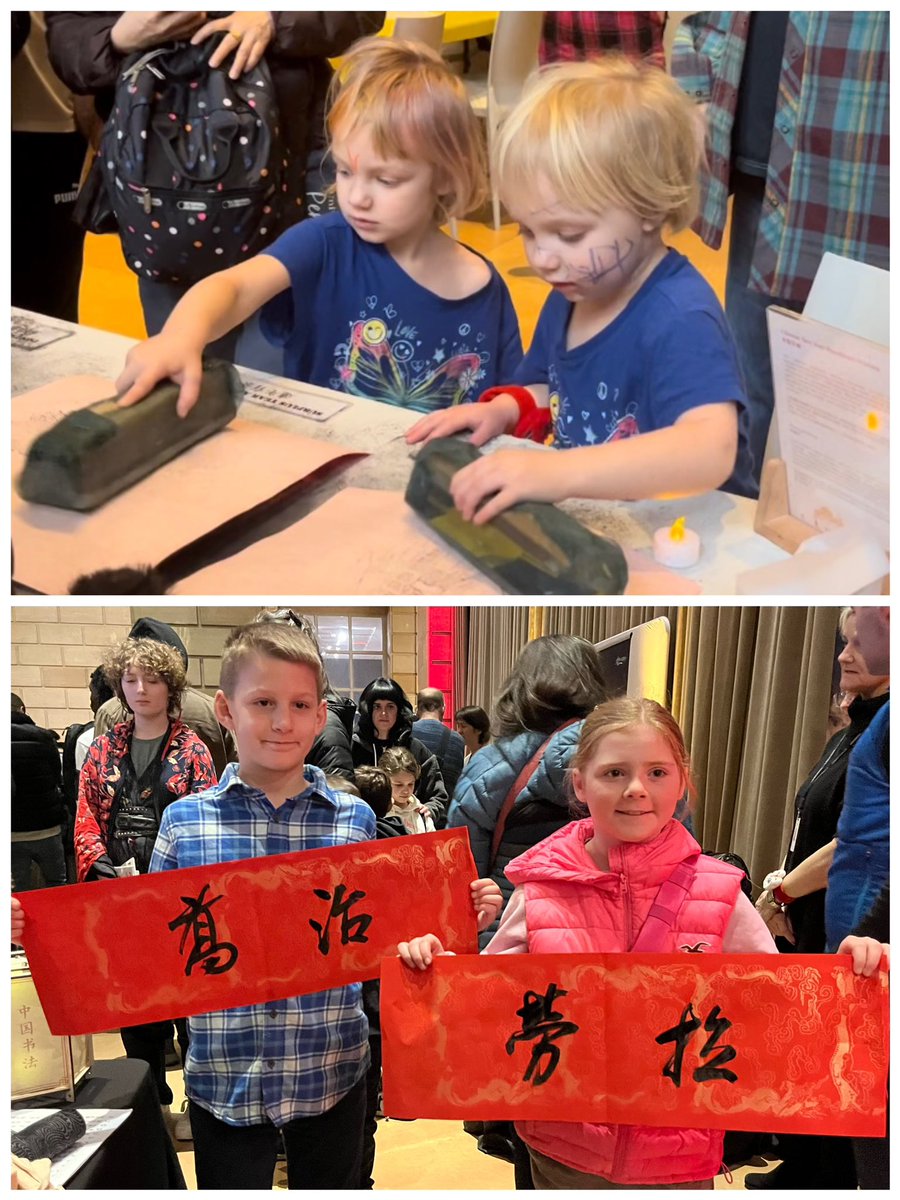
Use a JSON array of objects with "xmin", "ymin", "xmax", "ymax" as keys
[{"xmin": 11, "ymin": 605, "xmax": 427, "ymax": 732}]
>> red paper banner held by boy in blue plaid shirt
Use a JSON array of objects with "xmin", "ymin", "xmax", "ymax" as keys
[{"xmin": 19, "ymin": 829, "xmax": 478, "ymax": 1034}]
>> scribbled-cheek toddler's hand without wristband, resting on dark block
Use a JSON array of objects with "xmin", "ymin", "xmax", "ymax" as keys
[{"xmin": 450, "ymin": 450, "xmax": 571, "ymax": 524}]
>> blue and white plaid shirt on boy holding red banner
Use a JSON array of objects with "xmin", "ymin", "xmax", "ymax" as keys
[{"xmin": 150, "ymin": 763, "xmax": 376, "ymax": 1126}]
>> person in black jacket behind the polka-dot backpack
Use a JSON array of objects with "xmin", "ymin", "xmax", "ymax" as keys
[{"xmin": 46, "ymin": 11, "xmax": 384, "ymax": 360}]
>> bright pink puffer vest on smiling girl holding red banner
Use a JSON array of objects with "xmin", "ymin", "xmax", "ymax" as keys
[{"xmin": 506, "ymin": 820, "xmax": 740, "ymax": 1186}]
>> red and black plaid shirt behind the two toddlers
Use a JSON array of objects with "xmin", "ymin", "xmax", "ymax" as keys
[{"xmin": 540, "ymin": 12, "xmax": 666, "ymax": 67}]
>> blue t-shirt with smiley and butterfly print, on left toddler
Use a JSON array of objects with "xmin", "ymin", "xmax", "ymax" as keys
[{"xmin": 262, "ymin": 212, "xmax": 522, "ymax": 413}]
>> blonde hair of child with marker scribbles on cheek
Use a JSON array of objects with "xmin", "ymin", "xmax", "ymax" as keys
[{"xmin": 492, "ymin": 55, "xmax": 701, "ymax": 233}]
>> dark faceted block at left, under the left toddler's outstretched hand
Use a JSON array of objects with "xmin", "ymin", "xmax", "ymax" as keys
[{"xmin": 18, "ymin": 359, "xmax": 244, "ymax": 512}]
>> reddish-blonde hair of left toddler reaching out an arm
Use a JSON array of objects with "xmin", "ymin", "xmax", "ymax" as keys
[{"xmin": 326, "ymin": 37, "xmax": 487, "ymax": 220}]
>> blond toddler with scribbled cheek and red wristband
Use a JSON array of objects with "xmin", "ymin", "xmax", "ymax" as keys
[{"xmin": 407, "ymin": 58, "xmax": 756, "ymax": 524}]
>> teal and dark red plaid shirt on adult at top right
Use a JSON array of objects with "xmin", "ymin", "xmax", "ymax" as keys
[{"xmin": 672, "ymin": 12, "xmax": 890, "ymax": 301}]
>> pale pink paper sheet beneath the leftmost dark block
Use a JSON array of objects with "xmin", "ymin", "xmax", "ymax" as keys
[{"xmin": 12, "ymin": 376, "xmax": 362, "ymax": 594}]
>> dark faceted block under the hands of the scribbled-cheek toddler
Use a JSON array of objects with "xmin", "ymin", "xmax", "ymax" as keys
[{"xmin": 406, "ymin": 438, "xmax": 628, "ymax": 595}]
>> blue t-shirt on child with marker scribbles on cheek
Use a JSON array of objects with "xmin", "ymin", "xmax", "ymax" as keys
[{"xmin": 514, "ymin": 250, "xmax": 757, "ymax": 496}]
